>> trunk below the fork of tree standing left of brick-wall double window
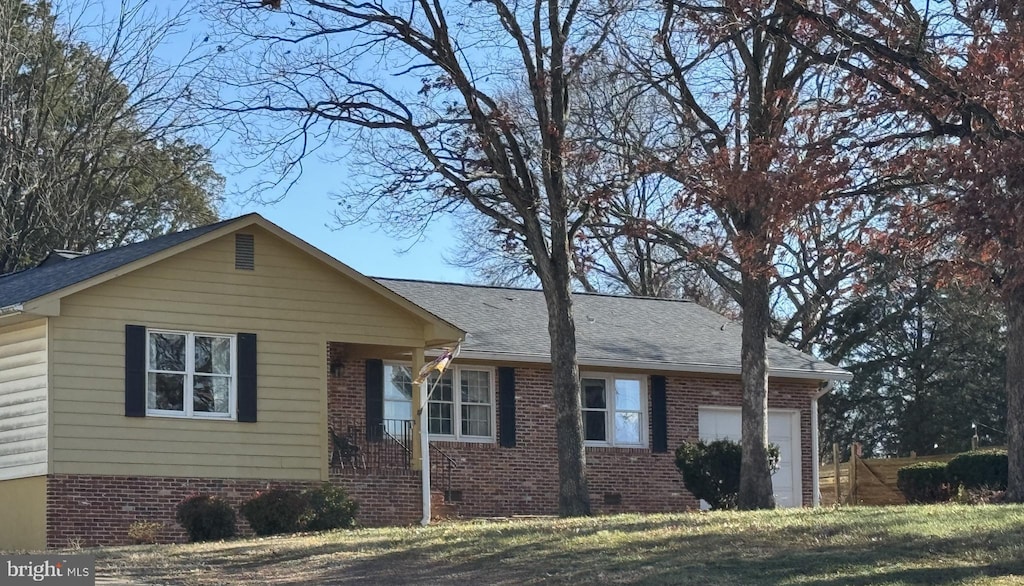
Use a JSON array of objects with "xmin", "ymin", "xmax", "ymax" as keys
[{"xmin": 543, "ymin": 263, "xmax": 590, "ymax": 516}]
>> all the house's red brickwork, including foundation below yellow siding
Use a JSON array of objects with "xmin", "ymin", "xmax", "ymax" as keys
[{"xmin": 46, "ymin": 346, "xmax": 817, "ymax": 547}]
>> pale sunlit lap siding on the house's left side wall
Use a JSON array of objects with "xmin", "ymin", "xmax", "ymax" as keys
[{"xmin": 0, "ymin": 319, "xmax": 47, "ymax": 481}]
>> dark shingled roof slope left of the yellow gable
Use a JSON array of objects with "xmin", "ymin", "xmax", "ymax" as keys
[{"xmin": 0, "ymin": 218, "xmax": 239, "ymax": 307}]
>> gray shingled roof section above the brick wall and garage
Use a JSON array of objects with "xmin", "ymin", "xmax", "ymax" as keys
[{"xmin": 377, "ymin": 279, "xmax": 850, "ymax": 380}]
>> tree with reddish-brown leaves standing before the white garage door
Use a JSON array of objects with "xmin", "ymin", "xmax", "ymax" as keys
[{"xmin": 621, "ymin": 0, "xmax": 892, "ymax": 508}]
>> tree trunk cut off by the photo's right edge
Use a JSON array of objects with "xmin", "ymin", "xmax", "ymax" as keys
[{"xmin": 1006, "ymin": 285, "xmax": 1024, "ymax": 503}]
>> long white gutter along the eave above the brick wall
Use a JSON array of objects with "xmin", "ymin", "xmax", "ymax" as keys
[{"xmin": 444, "ymin": 349, "xmax": 853, "ymax": 381}]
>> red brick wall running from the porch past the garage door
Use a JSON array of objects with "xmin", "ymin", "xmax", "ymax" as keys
[{"xmin": 328, "ymin": 345, "xmax": 818, "ymax": 524}]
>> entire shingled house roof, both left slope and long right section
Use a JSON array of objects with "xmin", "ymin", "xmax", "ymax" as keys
[{"xmin": 0, "ymin": 214, "xmax": 850, "ymax": 380}]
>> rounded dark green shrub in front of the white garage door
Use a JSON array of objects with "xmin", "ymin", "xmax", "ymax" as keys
[{"xmin": 676, "ymin": 440, "xmax": 779, "ymax": 509}]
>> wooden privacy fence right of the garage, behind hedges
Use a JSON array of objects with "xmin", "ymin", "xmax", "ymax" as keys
[{"xmin": 818, "ymin": 444, "xmax": 956, "ymax": 506}]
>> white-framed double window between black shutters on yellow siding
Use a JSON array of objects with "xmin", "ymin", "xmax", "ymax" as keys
[{"xmin": 145, "ymin": 330, "xmax": 238, "ymax": 419}]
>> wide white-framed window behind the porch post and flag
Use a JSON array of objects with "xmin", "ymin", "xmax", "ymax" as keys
[{"xmin": 384, "ymin": 363, "xmax": 496, "ymax": 442}]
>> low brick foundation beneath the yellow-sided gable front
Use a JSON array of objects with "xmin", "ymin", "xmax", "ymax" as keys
[{"xmin": 46, "ymin": 474, "xmax": 318, "ymax": 547}]
